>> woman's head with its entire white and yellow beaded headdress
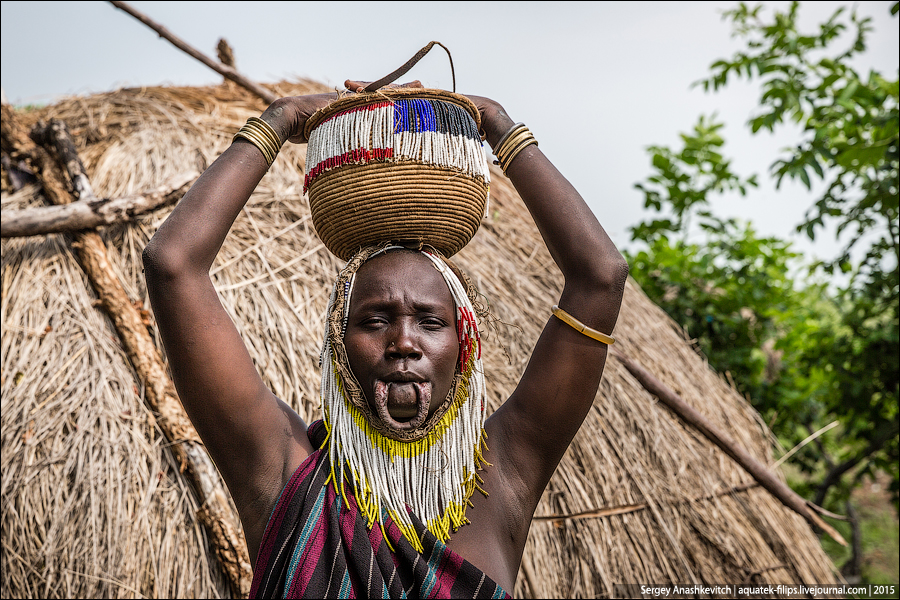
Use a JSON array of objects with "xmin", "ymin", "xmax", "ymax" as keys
[{"xmin": 322, "ymin": 247, "xmax": 485, "ymax": 541}]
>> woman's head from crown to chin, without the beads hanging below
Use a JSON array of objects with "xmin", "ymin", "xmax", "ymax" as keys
[{"xmin": 323, "ymin": 246, "xmax": 483, "ymax": 441}]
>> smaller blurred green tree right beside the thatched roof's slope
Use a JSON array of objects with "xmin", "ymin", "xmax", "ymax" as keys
[{"xmin": 629, "ymin": 117, "xmax": 796, "ymax": 408}]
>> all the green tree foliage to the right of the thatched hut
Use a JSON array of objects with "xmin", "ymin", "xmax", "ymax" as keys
[{"xmin": 629, "ymin": 2, "xmax": 900, "ymax": 536}]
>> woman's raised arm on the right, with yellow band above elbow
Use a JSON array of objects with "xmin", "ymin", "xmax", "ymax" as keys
[{"xmin": 471, "ymin": 97, "xmax": 628, "ymax": 510}]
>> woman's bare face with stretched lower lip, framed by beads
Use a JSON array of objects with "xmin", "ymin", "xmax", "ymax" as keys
[{"xmin": 344, "ymin": 251, "xmax": 459, "ymax": 431}]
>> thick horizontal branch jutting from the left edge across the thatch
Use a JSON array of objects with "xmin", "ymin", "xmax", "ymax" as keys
[{"xmin": 0, "ymin": 171, "xmax": 200, "ymax": 238}]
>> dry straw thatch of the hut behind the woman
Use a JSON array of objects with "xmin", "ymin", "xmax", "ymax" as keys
[{"xmin": 0, "ymin": 82, "xmax": 839, "ymax": 598}]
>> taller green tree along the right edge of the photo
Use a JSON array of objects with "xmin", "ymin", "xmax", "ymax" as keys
[{"xmin": 699, "ymin": 2, "xmax": 900, "ymax": 510}]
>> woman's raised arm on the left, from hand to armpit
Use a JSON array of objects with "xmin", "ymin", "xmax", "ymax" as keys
[{"xmin": 143, "ymin": 94, "xmax": 335, "ymax": 561}]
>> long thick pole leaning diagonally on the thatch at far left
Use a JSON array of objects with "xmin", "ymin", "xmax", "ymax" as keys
[{"xmin": 10, "ymin": 113, "xmax": 252, "ymax": 596}]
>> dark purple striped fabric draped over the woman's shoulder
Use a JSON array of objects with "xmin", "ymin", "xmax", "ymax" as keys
[{"xmin": 250, "ymin": 421, "xmax": 510, "ymax": 598}]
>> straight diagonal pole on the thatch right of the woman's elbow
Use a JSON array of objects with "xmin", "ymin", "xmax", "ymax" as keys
[{"xmin": 612, "ymin": 352, "xmax": 847, "ymax": 546}]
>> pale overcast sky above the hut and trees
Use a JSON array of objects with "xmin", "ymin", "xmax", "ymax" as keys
[{"xmin": 0, "ymin": 0, "xmax": 898, "ymax": 257}]
